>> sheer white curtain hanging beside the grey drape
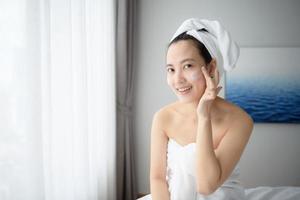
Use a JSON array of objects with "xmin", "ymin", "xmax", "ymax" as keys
[{"xmin": 0, "ymin": 0, "xmax": 116, "ymax": 200}]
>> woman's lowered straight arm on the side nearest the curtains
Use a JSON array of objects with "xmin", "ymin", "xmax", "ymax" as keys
[{"xmin": 150, "ymin": 111, "xmax": 170, "ymax": 200}]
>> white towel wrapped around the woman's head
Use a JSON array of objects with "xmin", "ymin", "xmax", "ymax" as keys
[{"xmin": 170, "ymin": 18, "xmax": 240, "ymax": 76}]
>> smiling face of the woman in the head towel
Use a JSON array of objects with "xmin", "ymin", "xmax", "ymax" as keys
[{"xmin": 166, "ymin": 40, "xmax": 206, "ymax": 102}]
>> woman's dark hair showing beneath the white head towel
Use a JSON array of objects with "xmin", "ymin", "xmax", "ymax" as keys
[{"xmin": 168, "ymin": 29, "xmax": 212, "ymax": 64}]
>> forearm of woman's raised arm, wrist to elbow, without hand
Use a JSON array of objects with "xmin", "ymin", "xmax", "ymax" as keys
[{"xmin": 196, "ymin": 117, "xmax": 221, "ymax": 194}]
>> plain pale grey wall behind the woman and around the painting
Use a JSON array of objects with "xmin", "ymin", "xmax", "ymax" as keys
[{"xmin": 134, "ymin": 0, "xmax": 300, "ymax": 192}]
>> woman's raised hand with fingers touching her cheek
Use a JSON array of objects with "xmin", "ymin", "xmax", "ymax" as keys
[{"xmin": 197, "ymin": 66, "xmax": 222, "ymax": 118}]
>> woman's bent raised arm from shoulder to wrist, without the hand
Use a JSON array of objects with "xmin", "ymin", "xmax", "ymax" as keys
[{"xmin": 196, "ymin": 113, "xmax": 253, "ymax": 195}]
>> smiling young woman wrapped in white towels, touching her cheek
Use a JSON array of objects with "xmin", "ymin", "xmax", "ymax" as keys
[{"xmin": 139, "ymin": 19, "xmax": 253, "ymax": 200}]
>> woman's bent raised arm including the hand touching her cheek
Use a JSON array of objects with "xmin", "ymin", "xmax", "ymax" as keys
[{"xmin": 196, "ymin": 65, "xmax": 253, "ymax": 195}]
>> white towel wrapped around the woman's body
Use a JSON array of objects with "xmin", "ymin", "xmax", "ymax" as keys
[{"xmin": 167, "ymin": 139, "xmax": 245, "ymax": 200}]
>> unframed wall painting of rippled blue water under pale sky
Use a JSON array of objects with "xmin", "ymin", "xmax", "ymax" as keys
[{"xmin": 225, "ymin": 48, "xmax": 300, "ymax": 123}]
